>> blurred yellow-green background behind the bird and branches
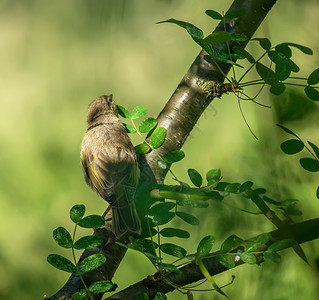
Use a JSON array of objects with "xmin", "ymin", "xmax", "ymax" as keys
[{"xmin": 0, "ymin": 0, "xmax": 319, "ymax": 300}]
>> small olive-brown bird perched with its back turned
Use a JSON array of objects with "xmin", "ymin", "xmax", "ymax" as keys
[{"xmin": 81, "ymin": 94, "xmax": 141, "ymax": 238}]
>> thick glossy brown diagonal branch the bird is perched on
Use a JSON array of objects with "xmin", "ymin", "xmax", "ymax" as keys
[{"xmin": 48, "ymin": 0, "xmax": 276, "ymax": 300}]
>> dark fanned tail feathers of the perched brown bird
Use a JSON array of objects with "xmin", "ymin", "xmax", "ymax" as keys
[{"xmin": 112, "ymin": 202, "xmax": 142, "ymax": 238}]
